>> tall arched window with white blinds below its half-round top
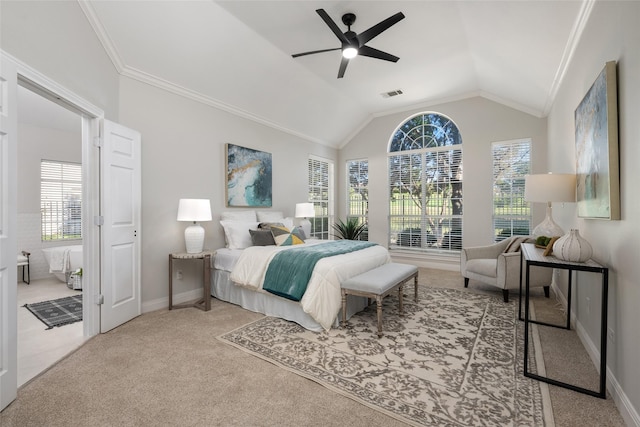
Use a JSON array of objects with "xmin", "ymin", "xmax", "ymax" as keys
[{"xmin": 389, "ymin": 112, "xmax": 463, "ymax": 252}]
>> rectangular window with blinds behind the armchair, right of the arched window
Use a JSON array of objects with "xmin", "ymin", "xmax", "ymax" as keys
[{"xmin": 491, "ymin": 139, "xmax": 531, "ymax": 242}]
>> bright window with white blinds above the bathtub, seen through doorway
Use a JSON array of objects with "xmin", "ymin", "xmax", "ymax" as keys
[{"xmin": 40, "ymin": 160, "xmax": 82, "ymax": 241}]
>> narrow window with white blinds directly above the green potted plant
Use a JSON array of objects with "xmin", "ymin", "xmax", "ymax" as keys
[{"xmin": 347, "ymin": 160, "xmax": 369, "ymax": 240}]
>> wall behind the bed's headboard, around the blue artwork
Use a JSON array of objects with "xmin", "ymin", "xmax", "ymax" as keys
[{"xmin": 120, "ymin": 77, "xmax": 337, "ymax": 309}]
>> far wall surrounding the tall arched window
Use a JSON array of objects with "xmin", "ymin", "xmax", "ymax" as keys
[{"xmin": 337, "ymin": 97, "xmax": 560, "ymax": 251}]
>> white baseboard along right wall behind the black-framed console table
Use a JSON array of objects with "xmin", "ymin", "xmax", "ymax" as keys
[{"xmin": 551, "ymin": 283, "xmax": 640, "ymax": 427}]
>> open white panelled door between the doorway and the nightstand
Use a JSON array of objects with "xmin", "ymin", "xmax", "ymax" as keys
[{"xmin": 100, "ymin": 120, "xmax": 141, "ymax": 332}]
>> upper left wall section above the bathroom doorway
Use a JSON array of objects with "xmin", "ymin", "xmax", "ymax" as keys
[{"xmin": 0, "ymin": 1, "xmax": 118, "ymax": 121}]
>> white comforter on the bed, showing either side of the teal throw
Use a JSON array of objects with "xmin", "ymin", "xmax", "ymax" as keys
[{"xmin": 231, "ymin": 241, "xmax": 391, "ymax": 330}]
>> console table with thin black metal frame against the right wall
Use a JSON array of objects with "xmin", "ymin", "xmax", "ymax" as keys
[{"xmin": 520, "ymin": 243, "xmax": 609, "ymax": 399}]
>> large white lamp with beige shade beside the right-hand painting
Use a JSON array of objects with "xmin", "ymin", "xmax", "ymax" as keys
[{"xmin": 524, "ymin": 173, "xmax": 576, "ymax": 241}]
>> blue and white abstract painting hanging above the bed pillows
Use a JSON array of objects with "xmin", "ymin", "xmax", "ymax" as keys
[{"xmin": 227, "ymin": 144, "xmax": 272, "ymax": 207}]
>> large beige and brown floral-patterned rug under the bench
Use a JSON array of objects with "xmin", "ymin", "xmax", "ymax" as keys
[{"xmin": 218, "ymin": 287, "xmax": 554, "ymax": 426}]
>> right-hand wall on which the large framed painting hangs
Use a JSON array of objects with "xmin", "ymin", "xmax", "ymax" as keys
[{"xmin": 548, "ymin": 1, "xmax": 640, "ymax": 425}]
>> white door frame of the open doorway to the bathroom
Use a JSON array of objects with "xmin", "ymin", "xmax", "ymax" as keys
[{"xmin": 6, "ymin": 50, "xmax": 104, "ymax": 337}]
